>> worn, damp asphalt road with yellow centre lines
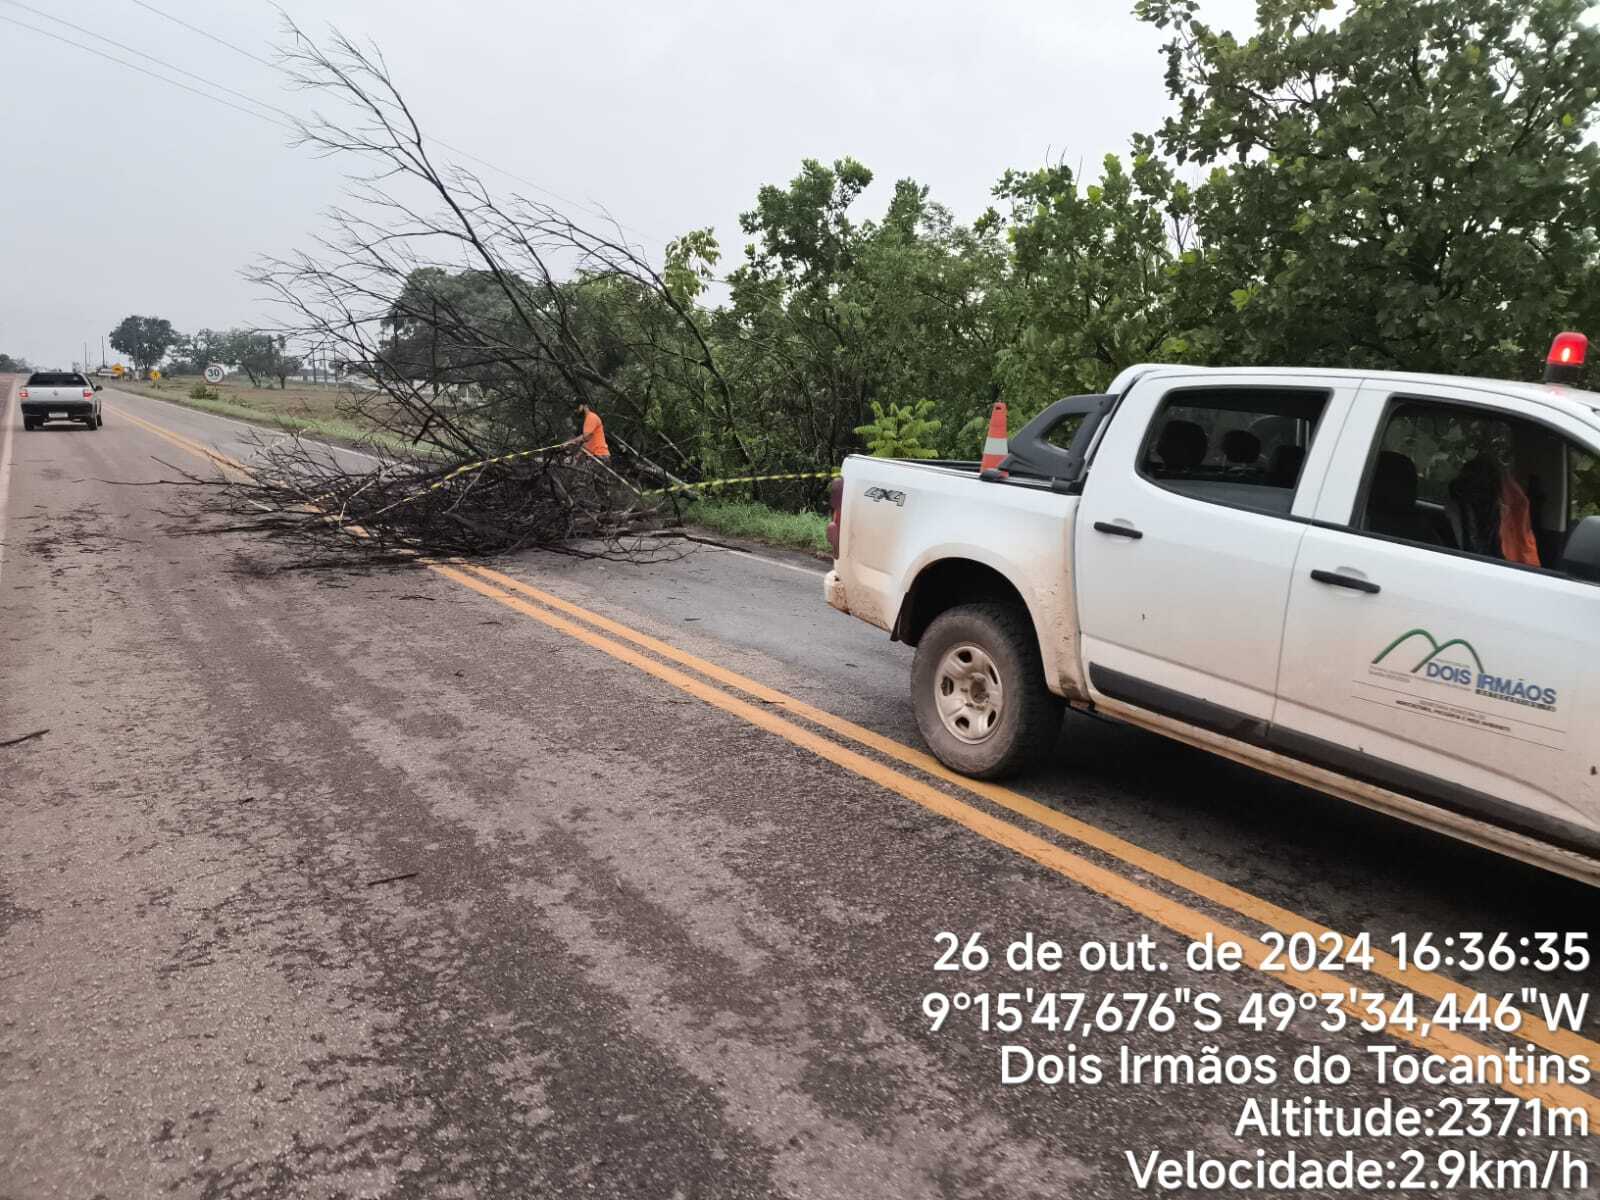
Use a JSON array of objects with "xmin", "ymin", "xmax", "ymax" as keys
[{"xmin": 0, "ymin": 382, "xmax": 1600, "ymax": 1200}]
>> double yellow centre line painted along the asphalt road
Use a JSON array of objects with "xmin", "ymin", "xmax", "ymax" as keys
[{"xmin": 120, "ymin": 404, "xmax": 1600, "ymax": 1126}]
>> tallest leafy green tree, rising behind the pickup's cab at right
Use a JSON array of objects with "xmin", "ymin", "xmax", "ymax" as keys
[{"xmin": 1136, "ymin": 0, "xmax": 1600, "ymax": 376}]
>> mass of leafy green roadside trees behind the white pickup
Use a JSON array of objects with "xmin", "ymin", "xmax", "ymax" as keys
[{"xmin": 686, "ymin": 0, "xmax": 1600, "ymax": 489}]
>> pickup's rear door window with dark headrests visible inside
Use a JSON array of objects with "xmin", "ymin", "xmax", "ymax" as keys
[{"xmin": 1139, "ymin": 387, "xmax": 1328, "ymax": 515}]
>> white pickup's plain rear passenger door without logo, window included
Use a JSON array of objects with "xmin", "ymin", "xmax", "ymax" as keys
[{"xmin": 1074, "ymin": 373, "xmax": 1358, "ymax": 739}]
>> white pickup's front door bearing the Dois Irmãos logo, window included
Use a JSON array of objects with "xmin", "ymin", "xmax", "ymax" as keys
[{"xmin": 1272, "ymin": 381, "xmax": 1600, "ymax": 848}]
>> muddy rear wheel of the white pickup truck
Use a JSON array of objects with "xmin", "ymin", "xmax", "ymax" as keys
[{"xmin": 910, "ymin": 603, "xmax": 1064, "ymax": 779}]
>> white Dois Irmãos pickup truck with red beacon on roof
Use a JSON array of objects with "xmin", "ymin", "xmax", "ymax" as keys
[{"xmin": 826, "ymin": 342, "xmax": 1600, "ymax": 885}]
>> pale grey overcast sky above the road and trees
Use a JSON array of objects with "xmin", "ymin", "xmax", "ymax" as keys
[{"xmin": 0, "ymin": 0, "xmax": 1254, "ymax": 365}]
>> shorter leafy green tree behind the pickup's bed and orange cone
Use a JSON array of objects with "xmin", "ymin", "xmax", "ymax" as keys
[{"xmin": 717, "ymin": 158, "xmax": 1006, "ymax": 469}]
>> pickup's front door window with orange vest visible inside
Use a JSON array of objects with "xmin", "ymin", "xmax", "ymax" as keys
[{"xmin": 1357, "ymin": 398, "xmax": 1600, "ymax": 579}]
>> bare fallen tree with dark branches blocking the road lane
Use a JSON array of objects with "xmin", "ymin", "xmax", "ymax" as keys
[{"xmin": 196, "ymin": 24, "xmax": 731, "ymax": 557}]
